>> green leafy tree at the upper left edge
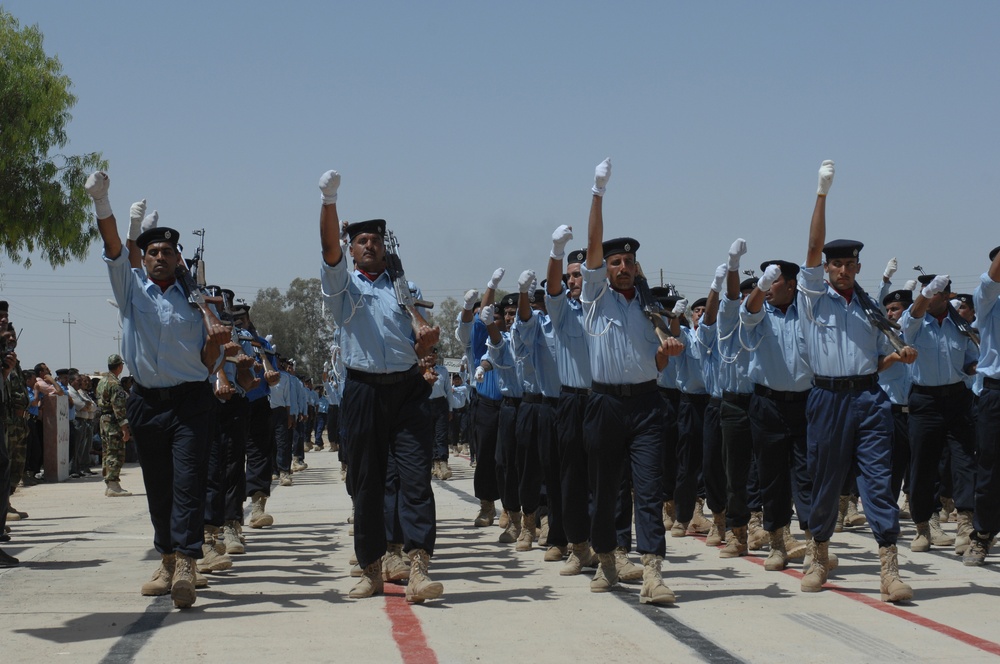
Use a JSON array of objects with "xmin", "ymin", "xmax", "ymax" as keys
[{"xmin": 0, "ymin": 8, "xmax": 107, "ymax": 267}]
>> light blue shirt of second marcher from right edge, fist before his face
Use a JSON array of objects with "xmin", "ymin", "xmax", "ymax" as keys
[{"xmin": 899, "ymin": 307, "xmax": 978, "ymax": 387}]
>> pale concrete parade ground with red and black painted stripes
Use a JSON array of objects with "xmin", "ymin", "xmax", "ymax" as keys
[{"xmin": 0, "ymin": 452, "xmax": 1000, "ymax": 664}]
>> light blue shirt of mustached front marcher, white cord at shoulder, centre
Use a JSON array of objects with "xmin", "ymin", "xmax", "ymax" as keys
[{"xmin": 580, "ymin": 263, "xmax": 660, "ymax": 385}]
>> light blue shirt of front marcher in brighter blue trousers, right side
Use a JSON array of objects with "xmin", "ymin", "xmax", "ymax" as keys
[{"xmin": 796, "ymin": 265, "xmax": 892, "ymax": 378}]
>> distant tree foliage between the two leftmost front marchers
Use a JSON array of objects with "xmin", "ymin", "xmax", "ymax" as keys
[{"xmin": 250, "ymin": 279, "xmax": 333, "ymax": 381}]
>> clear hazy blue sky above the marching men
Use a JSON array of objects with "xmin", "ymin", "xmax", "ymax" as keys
[{"xmin": 0, "ymin": 0, "xmax": 1000, "ymax": 370}]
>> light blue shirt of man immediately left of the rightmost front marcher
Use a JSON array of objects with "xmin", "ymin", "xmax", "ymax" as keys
[{"xmin": 740, "ymin": 300, "xmax": 813, "ymax": 392}]
